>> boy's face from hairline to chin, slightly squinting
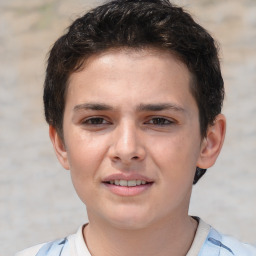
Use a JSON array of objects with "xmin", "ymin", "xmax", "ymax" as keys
[{"xmin": 52, "ymin": 49, "xmax": 210, "ymax": 228}]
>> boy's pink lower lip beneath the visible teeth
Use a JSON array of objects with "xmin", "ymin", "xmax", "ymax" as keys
[{"xmin": 104, "ymin": 183, "xmax": 153, "ymax": 196}]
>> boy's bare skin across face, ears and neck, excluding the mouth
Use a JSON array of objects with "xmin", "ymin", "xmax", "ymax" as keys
[{"xmin": 50, "ymin": 49, "xmax": 225, "ymax": 256}]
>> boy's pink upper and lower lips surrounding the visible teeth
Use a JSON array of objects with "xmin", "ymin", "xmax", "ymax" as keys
[{"xmin": 102, "ymin": 173, "xmax": 154, "ymax": 197}]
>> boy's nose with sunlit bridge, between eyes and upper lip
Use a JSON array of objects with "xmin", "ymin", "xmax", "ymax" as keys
[{"xmin": 109, "ymin": 121, "xmax": 146, "ymax": 165}]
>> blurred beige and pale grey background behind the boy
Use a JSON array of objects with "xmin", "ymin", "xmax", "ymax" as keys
[{"xmin": 0, "ymin": 0, "xmax": 256, "ymax": 256}]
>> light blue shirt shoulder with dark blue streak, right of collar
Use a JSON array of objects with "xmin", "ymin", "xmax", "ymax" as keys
[{"xmin": 199, "ymin": 228, "xmax": 256, "ymax": 256}]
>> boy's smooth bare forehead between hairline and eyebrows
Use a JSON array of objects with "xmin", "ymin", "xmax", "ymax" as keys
[{"xmin": 66, "ymin": 48, "xmax": 195, "ymax": 110}]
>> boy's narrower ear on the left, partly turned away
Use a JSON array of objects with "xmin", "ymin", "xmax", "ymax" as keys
[{"xmin": 49, "ymin": 125, "xmax": 70, "ymax": 170}]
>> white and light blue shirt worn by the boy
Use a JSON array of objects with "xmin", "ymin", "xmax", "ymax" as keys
[{"xmin": 15, "ymin": 219, "xmax": 256, "ymax": 256}]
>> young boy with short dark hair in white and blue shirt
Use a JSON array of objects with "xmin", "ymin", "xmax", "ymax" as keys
[{"xmin": 17, "ymin": 0, "xmax": 256, "ymax": 256}]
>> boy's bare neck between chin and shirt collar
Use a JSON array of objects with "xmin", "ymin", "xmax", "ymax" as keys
[{"xmin": 84, "ymin": 216, "xmax": 197, "ymax": 256}]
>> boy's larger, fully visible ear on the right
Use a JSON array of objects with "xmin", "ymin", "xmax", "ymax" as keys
[{"xmin": 197, "ymin": 114, "xmax": 226, "ymax": 169}]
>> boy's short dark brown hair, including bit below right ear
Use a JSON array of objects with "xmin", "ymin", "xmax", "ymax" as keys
[{"xmin": 44, "ymin": 0, "xmax": 224, "ymax": 183}]
